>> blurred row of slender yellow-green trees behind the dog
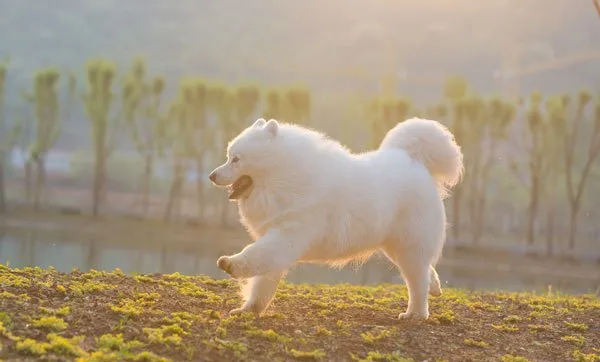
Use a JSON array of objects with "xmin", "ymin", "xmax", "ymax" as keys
[{"xmin": 0, "ymin": 58, "xmax": 600, "ymax": 254}]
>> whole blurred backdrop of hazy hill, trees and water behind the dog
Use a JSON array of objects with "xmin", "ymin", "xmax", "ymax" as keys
[{"xmin": 0, "ymin": 0, "xmax": 600, "ymax": 294}]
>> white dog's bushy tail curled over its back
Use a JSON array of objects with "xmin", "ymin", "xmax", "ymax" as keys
[{"xmin": 379, "ymin": 118, "xmax": 464, "ymax": 197}]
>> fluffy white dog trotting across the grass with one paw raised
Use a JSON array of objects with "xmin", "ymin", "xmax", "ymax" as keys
[{"xmin": 210, "ymin": 118, "xmax": 463, "ymax": 319}]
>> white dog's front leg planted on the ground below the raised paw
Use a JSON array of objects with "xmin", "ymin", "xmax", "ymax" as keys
[{"xmin": 229, "ymin": 273, "xmax": 283, "ymax": 316}]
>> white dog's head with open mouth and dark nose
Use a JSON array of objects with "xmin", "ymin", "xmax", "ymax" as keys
[{"xmin": 209, "ymin": 118, "xmax": 279, "ymax": 199}]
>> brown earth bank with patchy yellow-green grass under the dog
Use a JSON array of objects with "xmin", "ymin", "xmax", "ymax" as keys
[{"xmin": 0, "ymin": 265, "xmax": 600, "ymax": 361}]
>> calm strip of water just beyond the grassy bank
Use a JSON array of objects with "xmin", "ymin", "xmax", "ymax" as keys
[{"xmin": 0, "ymin": 231, "xmax": 600, "ymax": 294}]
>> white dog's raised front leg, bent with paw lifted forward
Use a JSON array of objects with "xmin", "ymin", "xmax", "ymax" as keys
[{"xmin": 217, "ymin": 228, "xmax": 307, "ymax": 279}]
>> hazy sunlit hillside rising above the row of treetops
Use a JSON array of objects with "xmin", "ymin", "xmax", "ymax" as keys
[{"xmin": 0, "ymin": 0, "xmax": 600, "ymax": 149}]
